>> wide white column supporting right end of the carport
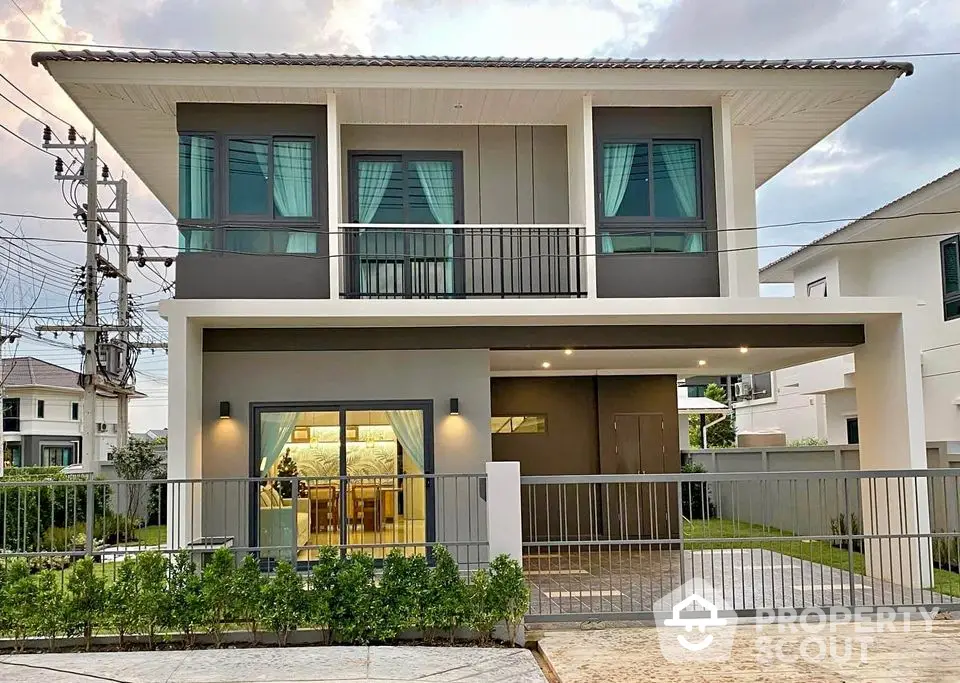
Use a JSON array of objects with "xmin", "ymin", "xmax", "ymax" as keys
[{"xmin": 850, "ymin": 311, "xmax": 932, "ymax": 588}]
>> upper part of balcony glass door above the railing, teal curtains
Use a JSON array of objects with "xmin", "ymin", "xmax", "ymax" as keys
[{"xmin": 350, "ymin": 152, "xmax": 463, "ymax": 225}]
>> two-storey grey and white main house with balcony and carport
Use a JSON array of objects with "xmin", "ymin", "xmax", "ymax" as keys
[{"xmin": 33, "ymin": 51, "xmax": 926, "ymax": 546}]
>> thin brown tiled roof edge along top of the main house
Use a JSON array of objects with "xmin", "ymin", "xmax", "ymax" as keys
[{"xmin": 32, "ymin": 50, "xmax": 913, "ymax": 76}]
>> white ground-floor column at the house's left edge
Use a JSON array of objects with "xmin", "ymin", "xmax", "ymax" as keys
[{"xmin": 167, "ymin": 315, "xmax": 203, "ymax": 550}]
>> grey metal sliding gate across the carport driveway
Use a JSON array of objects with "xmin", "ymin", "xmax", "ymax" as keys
[{"xmin": 521, "ymin": 469, "xmax": 960, "ymax": 621}]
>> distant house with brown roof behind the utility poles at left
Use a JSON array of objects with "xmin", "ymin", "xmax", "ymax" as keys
[{"xmin": 0, "ymin": 357, "xmax": 133, "ymax": 467}]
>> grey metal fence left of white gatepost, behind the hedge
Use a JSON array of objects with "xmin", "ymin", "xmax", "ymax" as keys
[{"xmin": 0, "ymin": 474, "xmax": 489, "ymax": 577}]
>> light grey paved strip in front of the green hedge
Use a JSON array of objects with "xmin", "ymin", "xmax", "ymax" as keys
[{"xmin": 0, "ymin": 647, "xmax": 546, "ymax": 683}]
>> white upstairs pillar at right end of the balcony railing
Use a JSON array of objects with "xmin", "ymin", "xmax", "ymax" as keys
[{"xmin": 567, "ymin": 93, "xmax": 597, "ymax": 299}]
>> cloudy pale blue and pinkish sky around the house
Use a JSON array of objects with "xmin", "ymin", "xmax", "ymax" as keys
[{"xmin": 0, "ymin": 0, "xmax": 960, "ymax": 431}]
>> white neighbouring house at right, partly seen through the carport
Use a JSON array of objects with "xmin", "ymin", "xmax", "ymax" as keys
[{"xmin": 737, "ymin": 169, "xmax": 960, "ymax": 449}]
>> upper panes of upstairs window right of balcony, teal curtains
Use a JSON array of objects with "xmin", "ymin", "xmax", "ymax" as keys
[{"xmin": 602, "ymin": 140, "xmax": 701, "ymax": 220}]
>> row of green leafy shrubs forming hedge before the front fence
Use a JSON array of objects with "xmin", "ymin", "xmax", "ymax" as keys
[{"xmin": 0, "ymin": 546, "xmax": 530, "ymax": 650}]
